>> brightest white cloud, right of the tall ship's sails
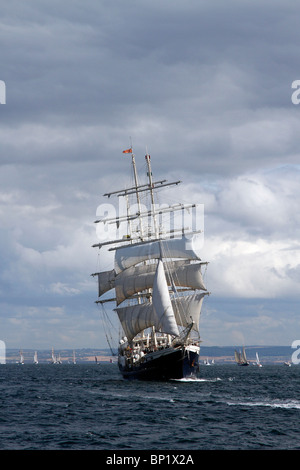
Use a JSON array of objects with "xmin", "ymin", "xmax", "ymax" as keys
[{"xmin": 205, "ymin": 237, "xmax": 300, "ymax": 298}]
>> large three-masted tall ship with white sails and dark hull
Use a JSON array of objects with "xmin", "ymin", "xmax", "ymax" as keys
[{"xmin": 92, "ymin": 148, "xmax": 209, "ymax": 380}]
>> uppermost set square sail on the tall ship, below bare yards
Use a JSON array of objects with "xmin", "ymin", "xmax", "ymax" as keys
[{"xmin": 115, "ymin": 235, "xmax": 202, "ymax": 274}]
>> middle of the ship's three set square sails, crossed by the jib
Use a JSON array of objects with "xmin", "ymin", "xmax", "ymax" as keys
[{"xmin": 115, "ymin": 260, "xmax": 206, "ymax": 305}]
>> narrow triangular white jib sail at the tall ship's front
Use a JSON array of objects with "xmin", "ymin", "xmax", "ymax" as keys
[{"xmin": 152, "ymin": 260, "xmax": 179, "ymax": 336}]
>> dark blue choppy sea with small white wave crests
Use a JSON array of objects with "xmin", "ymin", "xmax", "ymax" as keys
[{"xmin": 0, "ymin": 364, "xmax": 300, "ymax": 452}]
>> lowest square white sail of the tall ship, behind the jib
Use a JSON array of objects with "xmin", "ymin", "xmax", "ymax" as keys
[{"xmin": 116, "ymin": 292, "xmax": 207, "ymax": 341}]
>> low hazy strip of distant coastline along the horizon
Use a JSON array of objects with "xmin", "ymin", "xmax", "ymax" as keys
[{"xmin": 6, "ymin": 345, "xmax": 294, "ymax": 365}]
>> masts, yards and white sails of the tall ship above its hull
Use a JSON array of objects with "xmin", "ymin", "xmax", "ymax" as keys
[{"xmin": 93, "ymin": 148, "xmax": 208, "ymax": 352}]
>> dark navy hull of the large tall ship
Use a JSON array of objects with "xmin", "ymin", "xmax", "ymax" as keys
[{"xmin": 119, "ymin": 346, "xmax": 199, "ymax": 380}]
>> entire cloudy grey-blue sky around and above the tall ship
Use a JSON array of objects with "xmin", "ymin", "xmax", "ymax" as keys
[{"xmin": 0, "ymin": 0, "xmax": 300, "ymax": 349}]
